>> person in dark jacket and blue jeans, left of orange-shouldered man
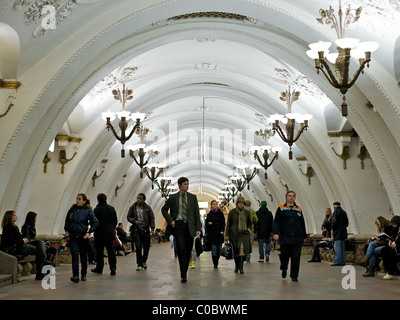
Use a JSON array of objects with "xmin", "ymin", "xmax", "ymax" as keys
[{"xmin": 255, "ymin": 201, "xmax": 274, "ymax": 262}]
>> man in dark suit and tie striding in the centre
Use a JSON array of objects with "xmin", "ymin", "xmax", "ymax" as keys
[{"xmin": 161, "ymin": 177, "xmax": 201, "ymax": 283}]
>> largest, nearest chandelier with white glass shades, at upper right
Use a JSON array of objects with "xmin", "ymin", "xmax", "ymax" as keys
[{"xmin": 307, "ymin": 0, "xmax": 379, "ymax": 116}]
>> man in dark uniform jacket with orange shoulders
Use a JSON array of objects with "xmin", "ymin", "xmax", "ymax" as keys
[{"xmin": 273, "ymin": 191, "xmax": 307, "ymax": 282}]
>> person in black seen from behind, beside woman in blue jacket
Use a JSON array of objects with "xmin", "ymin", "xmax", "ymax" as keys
[{"xmin": 92, "ymin": 193, "xmax": 118, "ymax": 275}]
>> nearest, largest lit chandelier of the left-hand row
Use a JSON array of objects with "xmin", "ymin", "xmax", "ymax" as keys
[{"xmin": 101, "ymin": 84, "xmax": 145, "ymax": 158}]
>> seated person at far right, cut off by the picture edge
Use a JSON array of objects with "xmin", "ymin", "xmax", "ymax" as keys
[{"xmin": 382, "ymin": 216, "xmax": 400, "ymax": 280}]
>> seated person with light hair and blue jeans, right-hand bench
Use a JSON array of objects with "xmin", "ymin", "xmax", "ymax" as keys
[{"xmin": 362, "ymin": 216, "xmax": 393, "ymax": 277}]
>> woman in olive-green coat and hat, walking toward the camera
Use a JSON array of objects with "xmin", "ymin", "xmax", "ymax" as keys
[{"xmin": 226, "ymin": 196, "xmax": 252, "ymax": 274}]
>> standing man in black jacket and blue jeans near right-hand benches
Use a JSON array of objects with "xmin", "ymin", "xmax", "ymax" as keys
[{"xmin": 331, "ymin": 201, "xmax": 349, "ymax": 266}]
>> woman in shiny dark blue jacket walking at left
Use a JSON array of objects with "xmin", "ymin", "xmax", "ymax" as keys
[{"xmin": 64, "ymin": 193, "xmax": 99, "ymax": 283}]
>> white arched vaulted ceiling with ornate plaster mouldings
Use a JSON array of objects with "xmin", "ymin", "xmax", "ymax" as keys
[{"xmin": 0, "ymin": 0, "xmax": 400, "ymax": 233}]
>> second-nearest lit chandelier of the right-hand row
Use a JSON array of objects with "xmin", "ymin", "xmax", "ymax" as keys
[{"xmin": 270, "ymin": 87, "xmax": 313, "ymax": 160}]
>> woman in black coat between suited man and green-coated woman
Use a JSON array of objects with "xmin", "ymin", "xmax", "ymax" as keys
[{"xmin": 206, "ymin": 200, "xmax": 225, "ymax": 268}]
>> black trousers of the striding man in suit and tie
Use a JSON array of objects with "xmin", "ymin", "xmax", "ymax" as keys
[{"xmin": 173, "ymin": 220, "xmax": 193, "ymax": 278}]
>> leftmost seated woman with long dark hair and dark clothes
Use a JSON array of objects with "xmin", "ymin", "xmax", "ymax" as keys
[{"xmin": 0, "ymin": 210, "xmax": 46, "ymax": 280}]
